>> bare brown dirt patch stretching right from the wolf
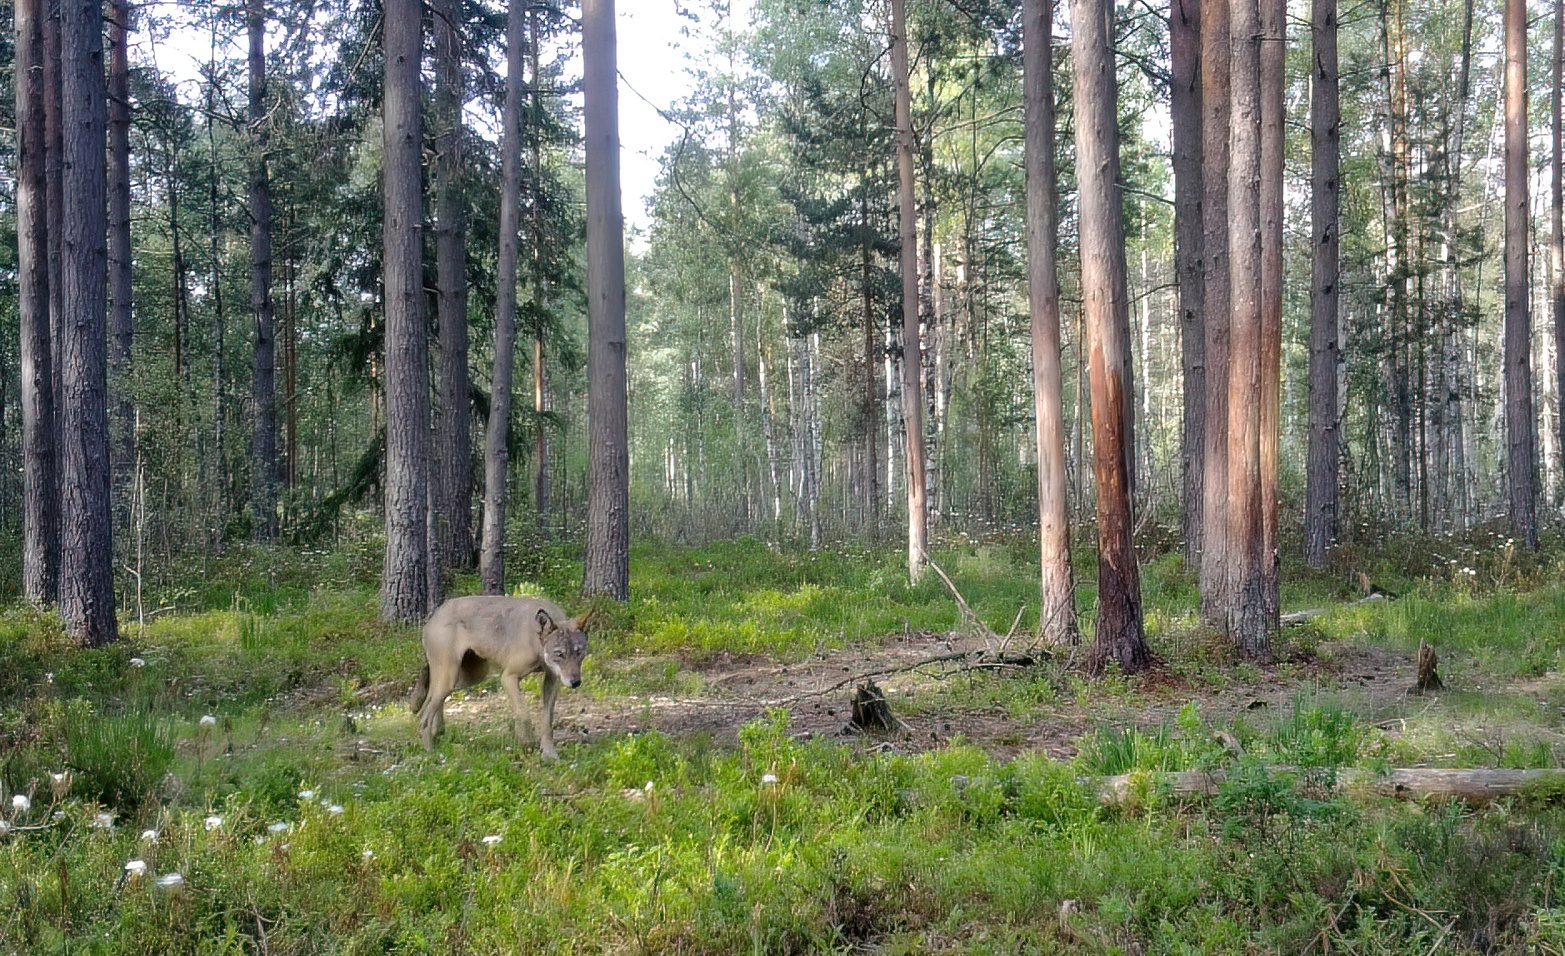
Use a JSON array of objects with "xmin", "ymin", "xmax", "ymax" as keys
[{"xmin": 446, "ymin": 634, "xmax": 1415, "ymax": 759}]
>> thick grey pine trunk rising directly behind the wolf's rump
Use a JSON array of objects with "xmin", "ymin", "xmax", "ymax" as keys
[{"xmin": 380, "ymin": 0, "xmax": 430, "ymax": 621}]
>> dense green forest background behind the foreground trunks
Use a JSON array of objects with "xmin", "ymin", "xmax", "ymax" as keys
[{"xmin": 0, "ymin": 0, "xmax": 1562, "ymax": 616}]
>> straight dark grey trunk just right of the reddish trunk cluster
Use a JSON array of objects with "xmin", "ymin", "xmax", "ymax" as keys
[{"xmin": 1304, "ymin": 0, "xmax": 1343, "ymax": 568}]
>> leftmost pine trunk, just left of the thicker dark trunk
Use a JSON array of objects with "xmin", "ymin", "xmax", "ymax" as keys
[{"xmin": 16, "ymin": 0, "xmax": 59, "ymax": 606}]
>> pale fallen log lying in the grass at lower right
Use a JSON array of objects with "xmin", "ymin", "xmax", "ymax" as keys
[{"xmin": 1097, "ymin": 767, "xmax": 1565, "ymax": 806}]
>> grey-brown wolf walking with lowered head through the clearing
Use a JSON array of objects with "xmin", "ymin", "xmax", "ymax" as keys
[{"xmin": 412, "ymin": 595, "xmax": 587, "ymax": 760}]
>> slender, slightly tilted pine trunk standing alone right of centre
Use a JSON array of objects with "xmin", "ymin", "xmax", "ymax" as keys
[{"xmin": 890, "ymin": 0, "xmax": 930, "ymax": 584}]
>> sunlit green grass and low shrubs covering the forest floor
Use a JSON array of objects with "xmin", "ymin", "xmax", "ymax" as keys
[{"xmin": 0, "ymin": 541, "xmax": 1565, "ymax": 953}]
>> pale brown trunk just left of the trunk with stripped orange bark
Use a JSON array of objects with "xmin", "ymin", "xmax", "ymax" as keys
[{"xmin": 1022, "ymin": 0, "xmax": 1081, "ymax": 645}]
